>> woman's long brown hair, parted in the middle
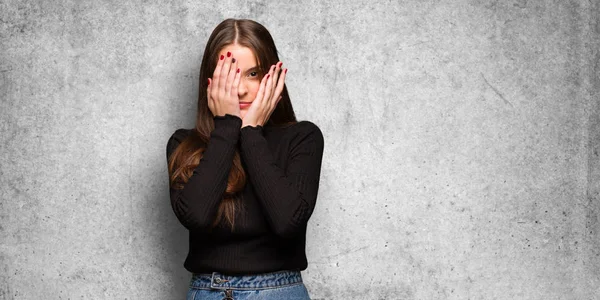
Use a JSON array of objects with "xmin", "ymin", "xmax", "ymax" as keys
[{"xmin": 168, "ymin": 19, "xmax": 297, "ymax": 230}]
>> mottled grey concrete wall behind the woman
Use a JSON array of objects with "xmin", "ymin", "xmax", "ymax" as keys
[{"xmin": 0, "ymin": 0, "xmax": 600, "ymax": 299}]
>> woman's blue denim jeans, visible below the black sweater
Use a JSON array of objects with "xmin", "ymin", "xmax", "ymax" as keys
[{"xmin": 187, "ymin": 271, "xmax": 310, "ymax": 300}]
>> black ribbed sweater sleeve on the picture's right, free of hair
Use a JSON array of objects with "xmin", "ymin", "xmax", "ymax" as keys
[{"xmin": 240, "ymin": 122, "xmax": 324, "ymax": 238}]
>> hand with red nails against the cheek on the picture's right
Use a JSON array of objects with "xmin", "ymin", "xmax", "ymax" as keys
[{"xmin": 242, "ymin": 62, "xmax": 287, "ymax": 128}]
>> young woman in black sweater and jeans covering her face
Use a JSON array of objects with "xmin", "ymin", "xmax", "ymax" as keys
[{"xmin": 167, "ymin": 19, "xmax": 324, "ymax": 300}]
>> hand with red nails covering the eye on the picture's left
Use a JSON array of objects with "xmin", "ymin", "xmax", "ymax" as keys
[{"xmin": 206, "ymin": 52, "xmax": 241, "ymax": 118}]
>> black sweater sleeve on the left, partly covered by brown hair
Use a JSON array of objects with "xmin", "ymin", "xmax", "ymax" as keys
[{"xmin": 167, "ymin": 114, "xmax": 242, "ymax": 230}]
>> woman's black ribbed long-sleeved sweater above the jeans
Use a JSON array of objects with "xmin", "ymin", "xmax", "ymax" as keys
[{"xmin": 167, "ymin": 114, "xmax": 324, "ymax": 275}]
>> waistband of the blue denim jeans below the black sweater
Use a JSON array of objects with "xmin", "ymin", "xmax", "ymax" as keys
[{"xmin": 190, "ymin": 271, "xmax": 302, "ymax": 290}]
